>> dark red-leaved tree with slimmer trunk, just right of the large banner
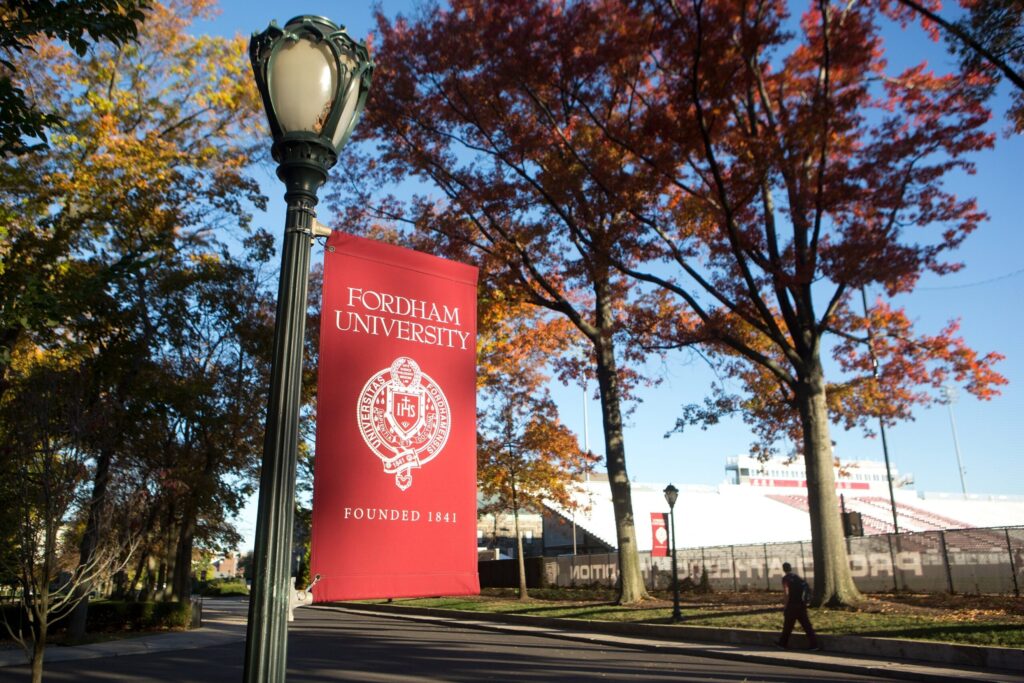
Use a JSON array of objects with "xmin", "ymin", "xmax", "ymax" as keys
[{"xmin": 339, "ymin": 1, "xmax": 667, "ymax": 602}]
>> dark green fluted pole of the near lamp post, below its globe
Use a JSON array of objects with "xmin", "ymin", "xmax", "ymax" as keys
[{"xmin": 244, "ymin": 142, "xmax": 330, "ymax": 683}]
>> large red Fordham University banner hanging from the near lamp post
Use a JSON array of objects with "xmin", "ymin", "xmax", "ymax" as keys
[{"xmin": 310, "ymin": 232, "xmax": 479, "ymax": 602}]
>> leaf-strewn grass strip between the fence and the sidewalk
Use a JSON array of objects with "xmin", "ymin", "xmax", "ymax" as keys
[{"xmin": 364, "ymin": 589, "xmax": 1024, "ymax": 647}]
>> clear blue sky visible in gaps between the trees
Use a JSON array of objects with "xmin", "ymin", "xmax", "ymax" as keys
[{"xmin": 194, "ymin": 0, "xmax": 1024, "ymax": 536}]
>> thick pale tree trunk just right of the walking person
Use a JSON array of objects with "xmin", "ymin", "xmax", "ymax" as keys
[{"xmin": 797, "ymin": 358, "xmax": 861, "ymax": 607}]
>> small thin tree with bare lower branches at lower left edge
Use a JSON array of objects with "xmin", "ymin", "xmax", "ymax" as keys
[{"xmin": 0, "ymin": 352, "xmax": 134, "ymax": 682}]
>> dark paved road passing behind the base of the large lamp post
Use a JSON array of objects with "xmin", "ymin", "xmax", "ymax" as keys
[{"xmin": 0, "ymin": 603, "xmax": 878, "ymax": 683}]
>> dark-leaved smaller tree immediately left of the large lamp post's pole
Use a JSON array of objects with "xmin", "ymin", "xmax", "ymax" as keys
[{"xmin": 142, "ymin": 249, "xmax": 269, "ymax": 600}]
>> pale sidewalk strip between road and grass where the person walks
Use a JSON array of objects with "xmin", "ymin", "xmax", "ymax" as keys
[{"xmin": 337, "ymin": 603, "xmax": 1024, "ymax": 683}]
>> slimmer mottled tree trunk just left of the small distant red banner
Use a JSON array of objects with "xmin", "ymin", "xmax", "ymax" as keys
[{"xmin": 595, "ymin": 331, "xmax": 648, "ymax": 604}]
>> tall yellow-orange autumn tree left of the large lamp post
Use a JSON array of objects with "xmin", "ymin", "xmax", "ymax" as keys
[{"xmin": 0, "ymin": 0, "xmax": 272, "ymax": 624}]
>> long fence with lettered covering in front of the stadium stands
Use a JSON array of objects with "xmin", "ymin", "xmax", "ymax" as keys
[{"xmin": 544, "ymin": 526, "xmax": 1024, "ymax": 595}]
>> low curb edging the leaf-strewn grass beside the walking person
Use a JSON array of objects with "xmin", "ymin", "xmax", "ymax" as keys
[{"xmin": 337, "ymin": 602, "xmax": 1024, "ymax": 682}]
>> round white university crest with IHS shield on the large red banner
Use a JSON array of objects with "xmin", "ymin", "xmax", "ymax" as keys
[{"xmin": 356, "ymin": 356, "xmax": 452, "ymax": 490}]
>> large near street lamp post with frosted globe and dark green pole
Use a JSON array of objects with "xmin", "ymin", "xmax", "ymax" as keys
[{"xmin": 244, "ymin": 16, "xmax": 373, "ymax": 683}]
